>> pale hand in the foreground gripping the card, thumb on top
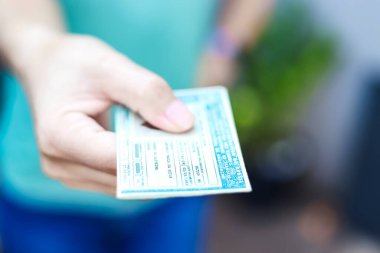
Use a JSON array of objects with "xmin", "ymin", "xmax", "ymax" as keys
[{"xmin": 18, "ymin": 32, "xmax": 194, "ymax": 195}]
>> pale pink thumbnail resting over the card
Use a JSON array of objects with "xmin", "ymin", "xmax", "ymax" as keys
[{"xmin": 165, "ymin": 99, "xmax": 194, "ymax": 131}]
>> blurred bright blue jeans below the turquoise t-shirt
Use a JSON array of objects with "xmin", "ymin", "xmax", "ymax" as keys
[{"xmin": 0, "ymin": 197, "xmax": 208, "ymax": 253}]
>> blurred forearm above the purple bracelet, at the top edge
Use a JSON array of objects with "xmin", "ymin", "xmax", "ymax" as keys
[{"xmin": 219, "ymin": 0, "xmax": 275, "ymax": 48}]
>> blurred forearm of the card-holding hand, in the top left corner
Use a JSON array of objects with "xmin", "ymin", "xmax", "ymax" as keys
[{"xmin": 0, "ymin": 0, "xmax": 64, "ymax": 73}]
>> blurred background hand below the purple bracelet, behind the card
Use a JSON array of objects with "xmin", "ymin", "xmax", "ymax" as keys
[{"xmin": 197, "ymin": 51, "xmax": 236, "ymax": 87}]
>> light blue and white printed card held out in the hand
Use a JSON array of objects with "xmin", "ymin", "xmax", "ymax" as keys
[{"xmin": 115, "ymin": 87, "xmax": 251, "ymax": 199}]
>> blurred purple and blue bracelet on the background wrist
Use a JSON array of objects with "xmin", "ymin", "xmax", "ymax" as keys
[{"xmin": 208, "ymin": 27, "xmax": 239, "ymax": 59}]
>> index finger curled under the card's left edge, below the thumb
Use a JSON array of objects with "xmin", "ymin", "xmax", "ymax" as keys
[{"xmin": 39, "ymin": 112, "xmax": 116, "ymax": 172}]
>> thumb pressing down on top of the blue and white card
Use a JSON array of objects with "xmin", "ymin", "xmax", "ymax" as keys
[{"xmin": 104, "ymin": 55, "xmax": 194, "ymax": 132}]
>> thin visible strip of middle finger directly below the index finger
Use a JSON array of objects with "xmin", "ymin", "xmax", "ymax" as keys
[{"xmin": 42, "ymin": 157, "xmax": 116, "ymax": 187}]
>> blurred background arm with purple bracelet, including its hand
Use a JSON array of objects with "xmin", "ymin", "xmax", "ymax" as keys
[{"xmin": 198, "ymin": 0, "xmax": 274, "ymax": 86}]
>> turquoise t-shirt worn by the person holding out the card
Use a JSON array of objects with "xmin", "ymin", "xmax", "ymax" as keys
[{"xmin": 0, "ymin": 0, "xmax": 218, "ymax": 215}]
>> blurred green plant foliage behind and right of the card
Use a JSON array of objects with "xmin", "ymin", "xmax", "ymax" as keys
[{"xmin": 231, "ymin": 1, "xmax": 335, "ymax": 150}]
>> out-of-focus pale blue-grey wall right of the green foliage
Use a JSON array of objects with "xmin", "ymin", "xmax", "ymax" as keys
[{"xmin": 304, "ymin": 0, "xmax": 380, "ymax": 188}]
